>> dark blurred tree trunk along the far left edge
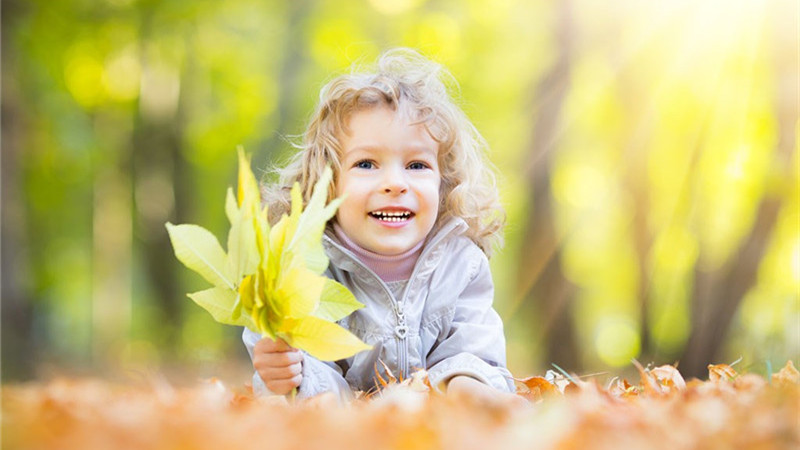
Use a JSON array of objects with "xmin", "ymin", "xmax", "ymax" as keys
[{"xmin": 0, "ymin": 1, "xmax": 38, "ymax": 382}]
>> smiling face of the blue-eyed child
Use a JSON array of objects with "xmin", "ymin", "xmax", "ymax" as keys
[{"xmin": 336, "ymin": 106, "xmax": 441, "ymax": 255}]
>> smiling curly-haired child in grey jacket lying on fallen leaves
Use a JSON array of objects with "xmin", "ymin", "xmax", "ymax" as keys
[{"xmin": 243, "ymin": 49, "xmax": 514, "ymax": 398}]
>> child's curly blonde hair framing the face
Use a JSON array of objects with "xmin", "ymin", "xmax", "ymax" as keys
[{"xmin": 262, "ymin": 48, "xmax": 506, "ymax": 256}]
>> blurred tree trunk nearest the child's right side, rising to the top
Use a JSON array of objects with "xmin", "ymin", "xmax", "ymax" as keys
[{"xmin": 519, "ymin": 1, "xmax": 581, "ymax": 371}]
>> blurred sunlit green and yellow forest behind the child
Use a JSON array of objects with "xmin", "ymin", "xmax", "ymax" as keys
[{"xmin": 0, "ymin": 0, "xmax": 800, "ymax": 383}]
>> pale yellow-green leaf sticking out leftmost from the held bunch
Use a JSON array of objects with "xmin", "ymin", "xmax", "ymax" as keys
[{"xmin": 167, "ymin": 222, "xmax": 234, "ymax": 289}]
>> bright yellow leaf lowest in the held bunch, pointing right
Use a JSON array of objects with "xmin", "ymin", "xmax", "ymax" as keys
[{"xmin": 278, "ymin": 316, "xmax": 372, "ymax": 361}]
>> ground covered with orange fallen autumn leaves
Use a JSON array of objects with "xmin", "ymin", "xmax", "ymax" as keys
[{"xmin": 2, "ymin": 362, "xmax": 800, "ymax": 449}]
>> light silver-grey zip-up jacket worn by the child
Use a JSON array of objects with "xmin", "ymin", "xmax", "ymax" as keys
[{"xmin": 242, "ymin": 219, "xmax": 514, "ymax": 399}]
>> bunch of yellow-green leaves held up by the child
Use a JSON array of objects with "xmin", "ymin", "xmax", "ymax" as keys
[{"xmin": 166, "ymin": 149, "xmax": 370, "ymax": 361}]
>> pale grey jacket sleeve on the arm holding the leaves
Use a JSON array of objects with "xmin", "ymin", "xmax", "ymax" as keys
[{"xmin": 242, "ymin": 328, "xmax": 353, "ymax": 401}]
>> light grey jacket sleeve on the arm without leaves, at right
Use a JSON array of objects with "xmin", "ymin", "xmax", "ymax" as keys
[{"xmin": 427, "ymin": 250, "xmax": 514, "ymax": 392}]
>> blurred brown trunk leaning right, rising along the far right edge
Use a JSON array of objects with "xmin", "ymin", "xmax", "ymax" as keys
[{"xmin": 679, "ymin": 12, "xmax": 800, "ymax": 378}]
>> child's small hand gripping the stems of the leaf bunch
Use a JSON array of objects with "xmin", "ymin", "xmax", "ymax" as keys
[{"xmin": 253, "ymin": 338, "xmax": 303, "ymax": 395}]
